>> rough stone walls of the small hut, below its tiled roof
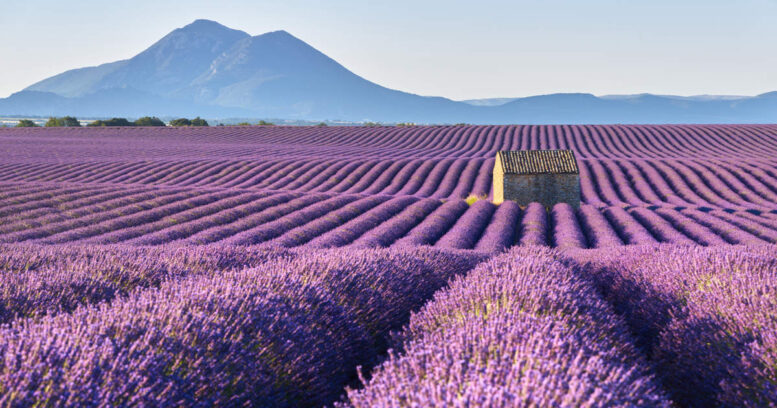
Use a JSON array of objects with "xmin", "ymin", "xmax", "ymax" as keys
[{"xmin": 494, "ymin": 174, "xmax": 580, "ymax": 208}]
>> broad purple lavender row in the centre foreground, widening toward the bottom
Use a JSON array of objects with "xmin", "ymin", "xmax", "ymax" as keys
[{"xmin": 348, "ymin": 247, "xmax": 670, "ymax": 407}]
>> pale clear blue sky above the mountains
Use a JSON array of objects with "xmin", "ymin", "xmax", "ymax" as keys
[{"xmin": 0, "ymin": 0, "xmax": 777, "ymax": 100}]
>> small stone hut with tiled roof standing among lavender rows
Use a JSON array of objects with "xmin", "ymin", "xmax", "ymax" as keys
[{"xmin": 494, "ymin": 150, "xmax": 580, "ymax": 208}]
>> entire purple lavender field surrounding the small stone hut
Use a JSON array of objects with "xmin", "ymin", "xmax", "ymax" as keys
[{"xmin": 0, "ymin": 125, "xmax": 777, "ymax": 407}]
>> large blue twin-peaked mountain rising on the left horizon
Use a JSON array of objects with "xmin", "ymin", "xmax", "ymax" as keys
[{"xmin": 12, "ymin": 20, "xmax": 467, "ymax": 122}]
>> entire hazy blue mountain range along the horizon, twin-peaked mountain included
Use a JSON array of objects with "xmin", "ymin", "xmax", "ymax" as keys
[{"xmin": 0, "ymin": 20, "xmax": 777, "ymax": 124}]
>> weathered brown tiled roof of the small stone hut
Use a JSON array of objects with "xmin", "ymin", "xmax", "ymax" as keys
[{"xmin": 496, "ymin": 150, "xmax": 580, "ymax": 174}]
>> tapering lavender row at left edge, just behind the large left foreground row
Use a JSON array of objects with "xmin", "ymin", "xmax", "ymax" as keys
[{"xmin": 0, "ymin": 244, "xmax": 286, "ymax": 324}]
